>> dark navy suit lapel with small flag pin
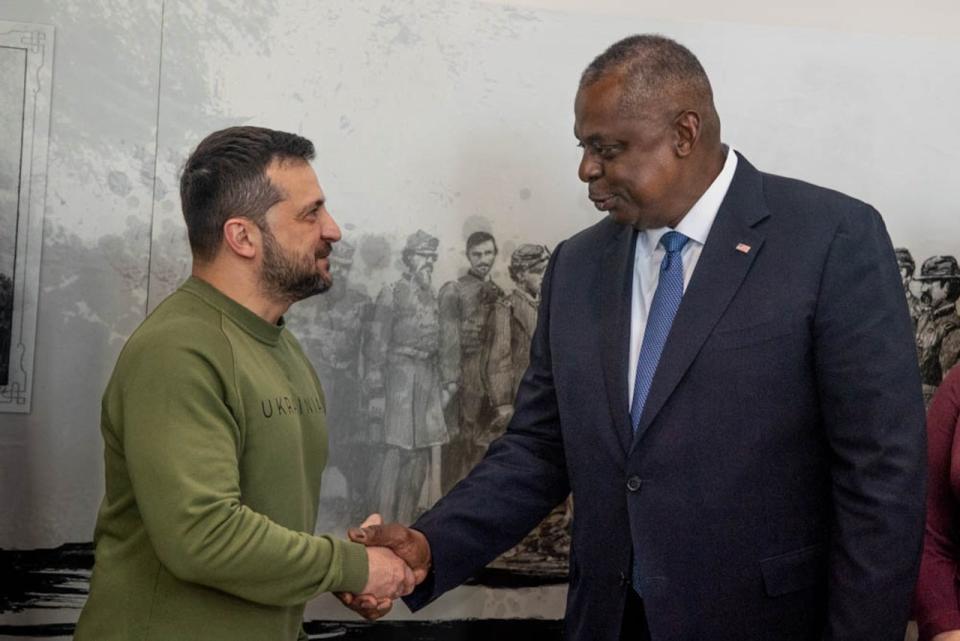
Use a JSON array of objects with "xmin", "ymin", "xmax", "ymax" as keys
[{"xmin": 633, "ymin": 156, "xmax": 770, "ymax": 447}]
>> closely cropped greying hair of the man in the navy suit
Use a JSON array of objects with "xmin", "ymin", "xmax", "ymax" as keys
[{"xmin": 580, "ymin": 34, "xmax": 720, "ymax": 146}]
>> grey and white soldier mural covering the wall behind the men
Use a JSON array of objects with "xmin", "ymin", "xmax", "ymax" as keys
[{"xmin": 0, "ymin": 0, "xmax": 960, "ymax": 641}]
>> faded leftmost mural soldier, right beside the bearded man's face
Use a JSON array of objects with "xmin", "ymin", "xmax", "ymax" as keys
[{"xmin": 301, "ymin": 240, "xmax": 377, "ymax": 521}]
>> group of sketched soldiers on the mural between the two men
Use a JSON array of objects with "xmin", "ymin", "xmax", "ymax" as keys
[{"xmin": 289, "ymin": 230, "xmax": 572, "ymax": 585}]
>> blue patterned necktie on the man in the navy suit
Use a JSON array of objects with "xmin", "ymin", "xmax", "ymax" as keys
[{"xmin": 630, "ymin": 231, "xmax": 690, "ymax": 434}]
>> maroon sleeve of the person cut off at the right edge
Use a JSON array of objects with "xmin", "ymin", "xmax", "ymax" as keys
[{"xmin": 914, "ymin": 370, "xmax": 960, "ymax": 639}]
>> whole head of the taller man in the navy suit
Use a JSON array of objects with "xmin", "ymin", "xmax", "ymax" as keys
[{"xmin": 573, "ymin": 35, "xmax": 727, "ymax": 230}]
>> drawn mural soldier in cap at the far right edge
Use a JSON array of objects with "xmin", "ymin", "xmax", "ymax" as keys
[{"xmin": 917, "ymin": 256, "xmax": 960, "ymax": 402}]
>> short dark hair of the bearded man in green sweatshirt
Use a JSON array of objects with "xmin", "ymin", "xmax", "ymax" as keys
[{"xmin": 180, "ymin": 127, "xmax": 314, "ymax": 261}]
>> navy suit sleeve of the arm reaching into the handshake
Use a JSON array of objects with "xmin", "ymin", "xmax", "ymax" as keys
[{"xmin": 404, "ymin": 244, "xmax": 570, "ymax": 610}]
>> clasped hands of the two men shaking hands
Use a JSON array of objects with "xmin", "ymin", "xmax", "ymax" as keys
[{"xmin": 336, "ymin": 514, "xmax": 430, "ymax": 621}]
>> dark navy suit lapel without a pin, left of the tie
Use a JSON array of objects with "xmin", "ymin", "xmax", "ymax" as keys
[{"xmin": 599, "ymin": 226, "xmax": 637, "ymax": 455}]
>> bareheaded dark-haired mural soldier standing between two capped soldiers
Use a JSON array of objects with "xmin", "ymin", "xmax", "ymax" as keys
[{"xmin": 439, "ymin": 231, "xmax": 503, "ymax": 493}]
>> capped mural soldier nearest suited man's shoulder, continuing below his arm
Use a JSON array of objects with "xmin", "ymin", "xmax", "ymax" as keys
[{"xmin": 486, "ymin": 245, "xmax": 573, "ymax": 572}]
